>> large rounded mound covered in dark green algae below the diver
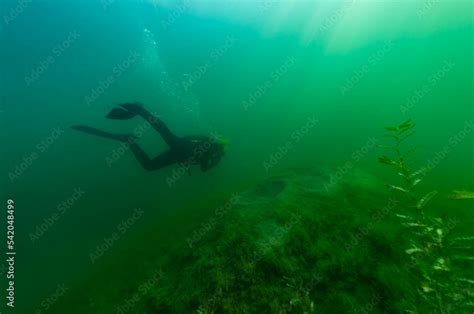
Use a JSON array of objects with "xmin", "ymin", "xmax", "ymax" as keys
[{"xmin": 53, "ymin": 168, "xmax": 424, "ymax": 314}]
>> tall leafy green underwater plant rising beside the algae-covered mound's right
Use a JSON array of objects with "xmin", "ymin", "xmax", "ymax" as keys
[{"xmin": 378, "ymin": 119, "xmax": 474, "ymax": 313}]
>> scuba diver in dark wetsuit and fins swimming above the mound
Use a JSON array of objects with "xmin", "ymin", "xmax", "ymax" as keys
[{"xmin": 71, "ymin": 102, "xmax": 226, "ymax": 173}]
